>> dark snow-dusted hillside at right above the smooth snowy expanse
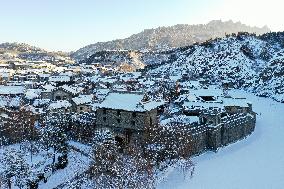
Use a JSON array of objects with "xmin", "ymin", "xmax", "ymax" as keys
[{"xmin": 148, "ymin": 32, "xmax": 284, "ymax": 102}]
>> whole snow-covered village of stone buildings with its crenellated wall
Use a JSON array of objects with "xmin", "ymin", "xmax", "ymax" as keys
[{"xmin": 0, "ymin": 60, "xmax": 255, "ymax": 154}]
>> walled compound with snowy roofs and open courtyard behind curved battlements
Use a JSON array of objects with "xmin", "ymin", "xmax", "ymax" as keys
[{"xmin": 170, "ymin": 89, "xmax": 256, "ymax": 154}]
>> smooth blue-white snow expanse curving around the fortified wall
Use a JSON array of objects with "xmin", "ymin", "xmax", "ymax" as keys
[{"xmin": 158, "ymin": 91, "xmax": 284, "ymax": 189}]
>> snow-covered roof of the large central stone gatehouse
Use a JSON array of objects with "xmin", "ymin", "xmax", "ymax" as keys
[{"xmin": 99, "ymin": 93, "xmax": 164, "ymax": 112}]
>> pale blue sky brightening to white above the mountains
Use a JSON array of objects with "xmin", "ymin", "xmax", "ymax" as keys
[{"xmin": 0, "ymin": 0, "xmax": 284, "ymax": 51}]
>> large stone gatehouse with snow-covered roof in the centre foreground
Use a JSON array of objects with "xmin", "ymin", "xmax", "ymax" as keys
[{"xmin": 96, "ymin": 92, "xmax": 164, "ymax": 143}]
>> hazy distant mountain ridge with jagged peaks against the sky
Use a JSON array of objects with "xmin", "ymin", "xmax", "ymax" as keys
[{"xmin": 72, "ymin": 20, "xmax": 270, "ymax": 60}]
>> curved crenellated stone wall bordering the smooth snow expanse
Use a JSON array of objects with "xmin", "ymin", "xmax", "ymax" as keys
[{"xmin": 186, "ymin": 113, "xmax": 255, "ymax": 155}]
